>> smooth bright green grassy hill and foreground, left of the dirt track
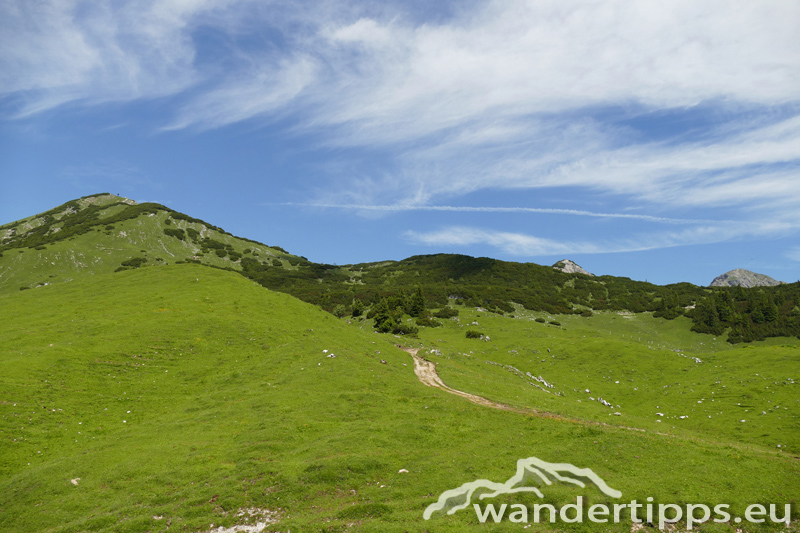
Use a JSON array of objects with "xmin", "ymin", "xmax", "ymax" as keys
[{"xmin": 0, "ymin": 265, "xmax": 800, "ymax": 531}]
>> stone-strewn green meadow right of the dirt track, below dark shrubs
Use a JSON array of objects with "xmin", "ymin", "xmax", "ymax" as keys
[{"xmin": 410, "ymin": 308, "xmax": 800, "ymax": 454}]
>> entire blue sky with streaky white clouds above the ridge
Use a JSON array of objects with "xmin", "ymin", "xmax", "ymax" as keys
[{"xmin": 0, "ymin": 0, "xmax": 800, "ymax": 285}]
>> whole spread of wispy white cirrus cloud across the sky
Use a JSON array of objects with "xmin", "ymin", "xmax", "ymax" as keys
[{"xmin": 0, "ymin": 0, "xmax": 800, "ymax": 256}]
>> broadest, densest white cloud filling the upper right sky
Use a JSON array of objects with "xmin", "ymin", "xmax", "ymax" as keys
[{"xmin": 306, "ymin": 0, "xmax": 800, "ymax": 144}]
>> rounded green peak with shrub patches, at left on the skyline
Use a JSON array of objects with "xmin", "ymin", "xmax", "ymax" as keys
[{"xmin": 0, "ymin": 193, "xmax": 307, "ymax": 292}]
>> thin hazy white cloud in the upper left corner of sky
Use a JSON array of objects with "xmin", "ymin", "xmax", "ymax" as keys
[{"xmin": 0, "ymin": 0, "xmax": 238, "ymax": 117}]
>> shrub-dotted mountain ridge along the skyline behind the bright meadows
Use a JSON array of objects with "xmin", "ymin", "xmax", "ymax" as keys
[{"xmin": 0, "ymin": 193, "xmax": 800, "ymax": 343}]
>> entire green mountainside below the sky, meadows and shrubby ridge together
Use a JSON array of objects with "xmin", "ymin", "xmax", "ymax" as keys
[{"xmin": 0, "ymin": 191, "xmax": 800, "ymax": 533}]
